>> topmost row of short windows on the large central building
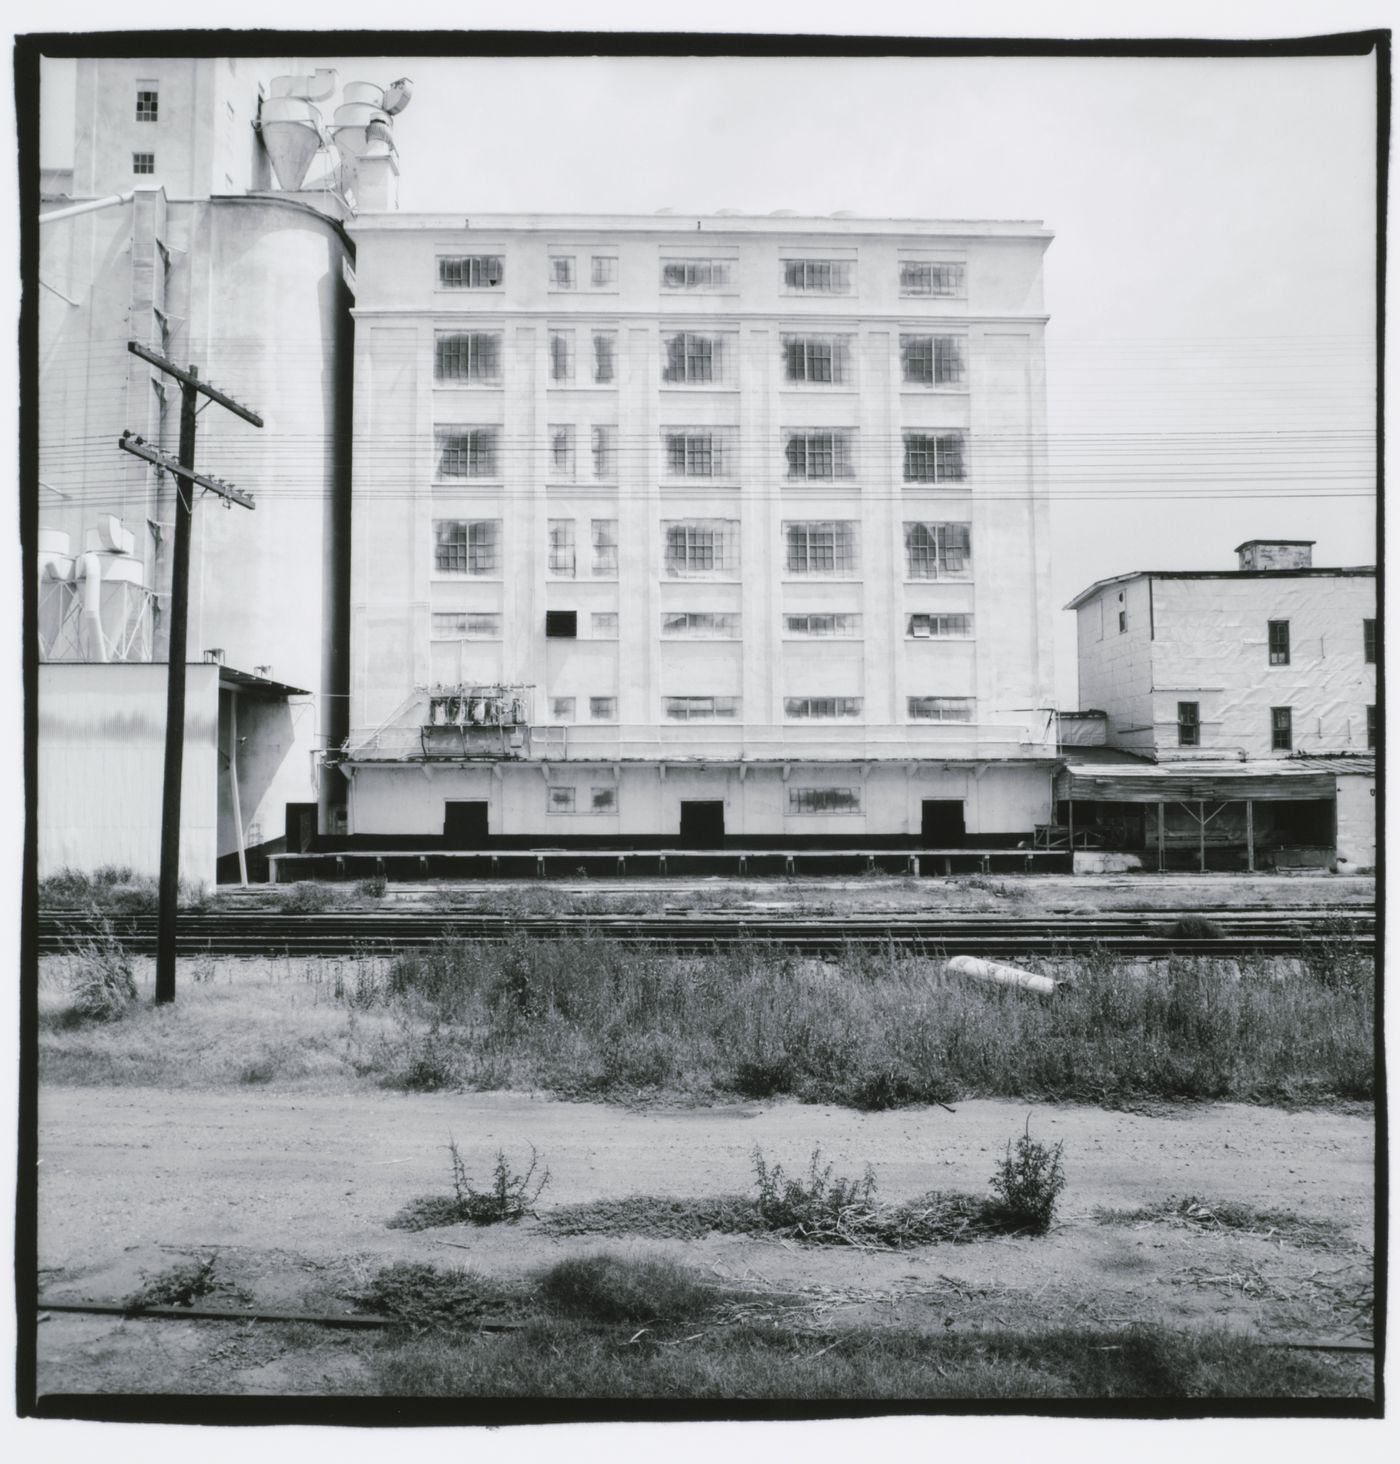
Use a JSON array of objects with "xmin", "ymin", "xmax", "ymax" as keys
[{"xmin": 436, "ymin": 253, "xmax": 967, "ymax": 300}]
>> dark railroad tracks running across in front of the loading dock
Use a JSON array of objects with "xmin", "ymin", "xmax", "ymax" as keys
[{"xmin": 38, "ymin": 909, "xmax": 1375, "ymax": 956}]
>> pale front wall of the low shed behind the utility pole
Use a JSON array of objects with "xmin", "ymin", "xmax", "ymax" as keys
[{"xmin": 38, "ymin": 663, "xmax": 218, "ymax": 884}]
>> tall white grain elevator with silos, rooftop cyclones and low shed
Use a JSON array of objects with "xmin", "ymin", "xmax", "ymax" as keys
[{"xmin": 35, "ymin": 57, "xmax": 410, "ymax": 881}]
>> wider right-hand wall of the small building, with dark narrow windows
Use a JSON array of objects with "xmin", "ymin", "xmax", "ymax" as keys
[{"xmin": 1153, "ymin": 575, "xmax": 1375, "ymax": 758}]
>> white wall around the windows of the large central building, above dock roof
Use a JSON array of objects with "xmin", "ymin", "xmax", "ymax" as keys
[{"xmin": 351, "ymin": 215, "xmax": 1053, "ymax": 829}]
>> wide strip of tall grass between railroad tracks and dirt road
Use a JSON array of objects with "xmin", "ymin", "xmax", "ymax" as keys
[{"xmin": 341, "ymin": 935, "xmax": 1375, "ymax": 1110}]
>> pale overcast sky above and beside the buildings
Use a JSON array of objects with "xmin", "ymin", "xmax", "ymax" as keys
[{"xmin": 35, "ymin": 42, "xmax": 1375, "ymax": 706}]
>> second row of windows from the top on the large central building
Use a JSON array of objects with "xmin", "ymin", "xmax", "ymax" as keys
[{"xmin": 433, "ymin": 332, "xmax": 967, "ymax": 386}]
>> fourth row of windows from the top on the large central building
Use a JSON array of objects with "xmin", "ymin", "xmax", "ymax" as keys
[{"xmin": 433, "ymin": 518, "xmax": 972, "ymax": 580}]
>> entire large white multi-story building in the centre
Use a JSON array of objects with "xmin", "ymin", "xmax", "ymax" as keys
[{"xmin": 340, "ymin": 212, "xmax": 1054, "ymax": 848}]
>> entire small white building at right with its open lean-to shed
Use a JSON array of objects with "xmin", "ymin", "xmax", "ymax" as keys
[{"xmin": 1059, "ymin": 539, "xmax": 1378, "ymax": 868}]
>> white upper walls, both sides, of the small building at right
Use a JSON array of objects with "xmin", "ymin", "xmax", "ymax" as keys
[{"xmin": 1072, "ymin": 568, "xmax": 1377, "ymax": 761}]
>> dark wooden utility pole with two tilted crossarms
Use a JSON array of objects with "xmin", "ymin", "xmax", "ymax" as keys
[{"xmin": 117, "ymin": 341, "xmax": 262, "ymax": 1003}]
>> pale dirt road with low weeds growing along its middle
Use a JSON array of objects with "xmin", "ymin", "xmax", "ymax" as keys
[{"xmin": 40, "ymin": 1088, "xmax": 1374, "ymax": 1392}]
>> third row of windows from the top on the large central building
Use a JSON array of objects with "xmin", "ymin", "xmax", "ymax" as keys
[{"xmin": 433, "ymin": 423, "xmax": 968, "ymax": 483}]
